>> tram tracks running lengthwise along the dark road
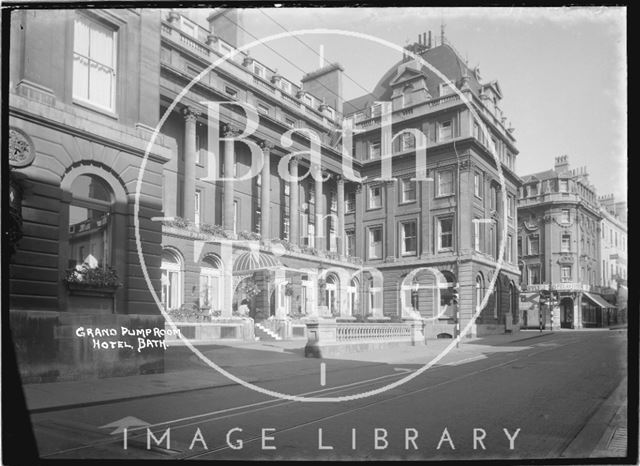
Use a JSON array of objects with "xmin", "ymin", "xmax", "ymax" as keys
[{"xmin": 37, "ymin": 337, "xmax": 596, "ymax": 459}]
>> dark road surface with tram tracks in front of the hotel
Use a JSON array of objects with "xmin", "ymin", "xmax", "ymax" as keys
[{"xmin": 32, "ymin": 331, "xmax": 626, "ymax": 460}]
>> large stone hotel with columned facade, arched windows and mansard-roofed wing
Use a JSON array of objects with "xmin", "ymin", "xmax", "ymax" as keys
[{"xmin": 9, "ymin": 8, "xmax": 524, "ymax": 380}]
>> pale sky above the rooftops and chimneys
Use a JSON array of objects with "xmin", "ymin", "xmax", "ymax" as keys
[{"xmin": 201, "ymin": 7, "xmax": 627, "ymax": 199}]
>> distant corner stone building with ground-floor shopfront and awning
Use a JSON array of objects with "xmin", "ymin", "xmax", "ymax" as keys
[{"xmin": 518, "ymin": 155, "xmax": 612, "ymax": 328}]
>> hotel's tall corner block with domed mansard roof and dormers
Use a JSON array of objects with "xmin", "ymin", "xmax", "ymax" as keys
[{"xmin": 344, "ymin": 32, "xmax": 521, "ymax": 336}]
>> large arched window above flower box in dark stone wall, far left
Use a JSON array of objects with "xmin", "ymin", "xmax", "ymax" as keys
[{"xmin": 68, "ymin": 175, "xmax": 114, "ymax": 268}]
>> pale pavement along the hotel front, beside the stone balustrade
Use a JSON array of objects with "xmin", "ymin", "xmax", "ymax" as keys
[{"xmin": 23, "ymin": 330, "xmax": 564, "ymax": 413}]
